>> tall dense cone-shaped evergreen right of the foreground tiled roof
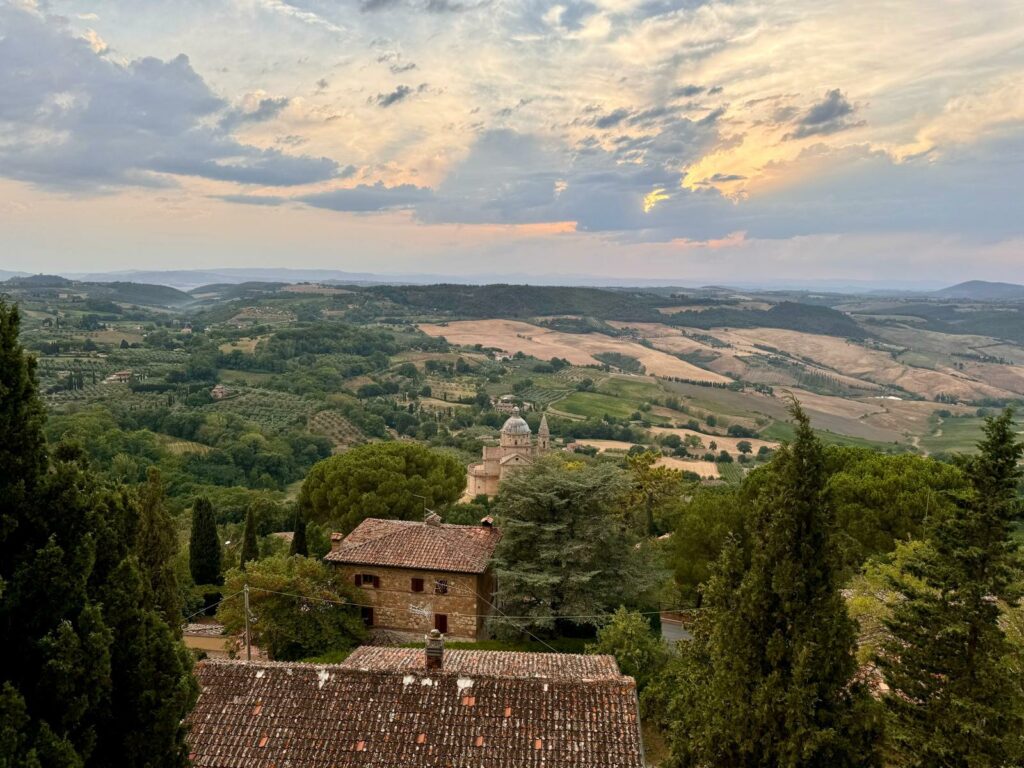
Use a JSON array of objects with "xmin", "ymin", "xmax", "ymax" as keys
[{"xmin": 671, "ymin": 403, "xmax": 879, "ymax": 768}]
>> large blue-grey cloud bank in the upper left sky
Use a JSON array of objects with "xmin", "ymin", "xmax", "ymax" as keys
[{"xmin": 0, "ymin": 5, "xmax": 338, "ymax": 188}]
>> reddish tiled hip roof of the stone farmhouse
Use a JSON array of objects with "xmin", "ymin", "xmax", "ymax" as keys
[{"xmin": 324, "ymin": 517, "xmax": 502, "ymax": 573}]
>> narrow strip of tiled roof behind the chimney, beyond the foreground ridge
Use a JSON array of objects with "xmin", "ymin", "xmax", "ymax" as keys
[{"xmin": 341, "ymin": 645, "xmax": 623, "ymax": 681}]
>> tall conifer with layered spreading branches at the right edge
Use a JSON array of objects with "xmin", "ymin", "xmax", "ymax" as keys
[{"xmin": 880, "ymin": 410, "xmax": 1024, "ymax": 768}]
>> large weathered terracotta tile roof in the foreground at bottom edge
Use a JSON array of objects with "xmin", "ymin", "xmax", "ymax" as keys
[{"xmin": 188, "ymin": 651, "xmax": 643, "ymax": 768}]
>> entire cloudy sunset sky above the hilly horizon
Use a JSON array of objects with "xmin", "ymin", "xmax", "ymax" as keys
[{"xmin": 0, "ymin": 0, "xmax": 1024, "ymax": 282}]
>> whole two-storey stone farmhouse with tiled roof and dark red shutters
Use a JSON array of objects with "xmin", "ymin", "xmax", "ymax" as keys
[{"xmin": 324, "ymin": 513, "xmax": 501, "ymax": 640}]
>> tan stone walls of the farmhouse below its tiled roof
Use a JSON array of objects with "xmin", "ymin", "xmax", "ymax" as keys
[{"xmin": 335, "ymin": 564, "xmax": 493, "ymax": 640}]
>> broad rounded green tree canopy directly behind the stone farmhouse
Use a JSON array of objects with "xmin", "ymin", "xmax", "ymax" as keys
[{"xmin": 299, "ymin": 441, "xmax": 466, "ymax": 534}]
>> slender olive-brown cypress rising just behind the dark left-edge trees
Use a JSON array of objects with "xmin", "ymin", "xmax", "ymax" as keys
[{"xmin": 134, "ymin": 467, "xmax": 181, "ymax": 627}]
